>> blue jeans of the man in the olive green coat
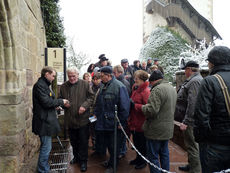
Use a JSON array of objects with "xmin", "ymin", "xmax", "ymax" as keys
[{"xmin": 146, "ymin": 139, "xmax": 169, "ymax": 173}]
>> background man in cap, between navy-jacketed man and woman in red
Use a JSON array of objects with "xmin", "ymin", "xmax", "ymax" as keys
[{"xmin": 121, "ymin": 59, "xmax": 134, "ymax": 88}]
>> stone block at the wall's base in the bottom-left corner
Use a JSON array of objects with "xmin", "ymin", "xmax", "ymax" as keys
[{"xmin": 0, "ymin": 156, "xmax": 19, "ymax": 173}]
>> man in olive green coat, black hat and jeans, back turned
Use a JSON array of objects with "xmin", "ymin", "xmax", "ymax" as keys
[{"xmin": 142, "ymin": 70, "xmax": 177, "ymax": 173}]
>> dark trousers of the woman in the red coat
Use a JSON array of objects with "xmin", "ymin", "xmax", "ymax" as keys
[{"xmin": 131, "ymin": 131, "xmax": 146, "ymax": 164}]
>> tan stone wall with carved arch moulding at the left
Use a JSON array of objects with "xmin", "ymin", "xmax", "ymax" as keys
[{"xmin": 0, "ymin": 0, "xmax": 46, "ymax": 173}]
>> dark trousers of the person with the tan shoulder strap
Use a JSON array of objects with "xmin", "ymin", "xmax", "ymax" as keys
[{"xmin": 199, "ymin": 143, "xmax": 230, "ymax": 173}]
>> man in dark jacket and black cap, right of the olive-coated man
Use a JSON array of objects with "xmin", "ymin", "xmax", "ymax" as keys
[{"xmin": 175, "ymin": 61, "xmax": 203, "ymax": 173}]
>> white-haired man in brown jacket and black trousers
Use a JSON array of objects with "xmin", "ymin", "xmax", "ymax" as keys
[{"xmin": 60, "ymin": 67, "xmax": 94, "ymax": 172}]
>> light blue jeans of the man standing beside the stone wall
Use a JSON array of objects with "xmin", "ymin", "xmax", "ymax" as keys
[{"xmin": 37, "ymin": 136, "xmax": 52, "ymax": 173}]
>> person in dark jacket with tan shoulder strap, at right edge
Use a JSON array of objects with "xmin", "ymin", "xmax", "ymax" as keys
[{"xmin": 194, "ymin": 46, "xmax": 230, "ymax": 173}]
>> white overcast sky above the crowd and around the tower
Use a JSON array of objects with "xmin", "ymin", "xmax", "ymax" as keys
[{"xmin": 59, "ymin": 0, "xmax": 230, "ymax": 65}]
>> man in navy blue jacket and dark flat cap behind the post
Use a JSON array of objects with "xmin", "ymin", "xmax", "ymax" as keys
[{"xmin": 95, "ymin": 66, "xmax": 129, "ymax": 172}]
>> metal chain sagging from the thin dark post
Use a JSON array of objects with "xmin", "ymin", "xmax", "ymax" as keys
[{"xmin": 115, "ymin": 114, "xmax": 175, "ymax": 173}]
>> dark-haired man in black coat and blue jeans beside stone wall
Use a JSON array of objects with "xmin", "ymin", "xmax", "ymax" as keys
[{"xmin": 32, "ymin": 66, "xmax": 68, "ymax": 173}]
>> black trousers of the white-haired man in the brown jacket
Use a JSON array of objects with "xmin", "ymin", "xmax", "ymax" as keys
[{"xmin": 69, "ymin": 125, "xmax": 89, "ymax": 162}]
